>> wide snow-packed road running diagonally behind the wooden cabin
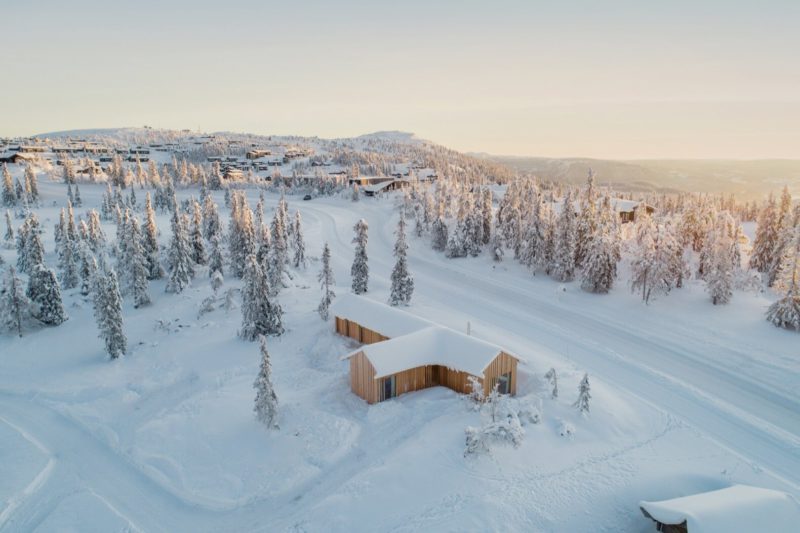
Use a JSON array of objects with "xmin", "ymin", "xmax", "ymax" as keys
[{"xmin": 304, "ymin": 200, "xmax": 800, "ymax": 490}]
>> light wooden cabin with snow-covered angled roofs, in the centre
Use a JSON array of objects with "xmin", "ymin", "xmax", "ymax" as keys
[{"xmin": 333, "ymin": 294, "xmax": 519, "ymax": 403}]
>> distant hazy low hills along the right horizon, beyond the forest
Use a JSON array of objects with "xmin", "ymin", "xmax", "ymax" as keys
[{"xmin": 471, "ymin": 154, "xmax": 800, "ymax": 198}]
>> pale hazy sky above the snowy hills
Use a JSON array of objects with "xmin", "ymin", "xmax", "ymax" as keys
[{"xmin": 0, "ymin": 0, "xmax": 800, "ymax": 159}]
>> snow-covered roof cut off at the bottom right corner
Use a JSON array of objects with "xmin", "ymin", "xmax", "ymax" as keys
[{"xmin": 639, "ymin": 485, "xmax": 800, "ymax": 533}]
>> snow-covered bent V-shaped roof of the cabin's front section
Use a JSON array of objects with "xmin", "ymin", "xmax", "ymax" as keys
[{"xmin": 343, "ymin": 325, "xmax": 513, "ymax": 379}]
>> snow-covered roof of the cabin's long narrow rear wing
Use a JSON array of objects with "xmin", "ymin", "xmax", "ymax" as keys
[{"xmin": 331, "ymin": 293, "xmax": 435, "ymax": 338}]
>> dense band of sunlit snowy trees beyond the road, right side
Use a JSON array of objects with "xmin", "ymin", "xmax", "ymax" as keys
[{"xmin": 402, "ymin": 172, "xmax": 800, "ymax": 330}]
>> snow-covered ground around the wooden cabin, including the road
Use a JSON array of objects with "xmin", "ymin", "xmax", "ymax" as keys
[{"xmin": 0, "ymin": 179, "xmax": 800, "ymax": 532}]
